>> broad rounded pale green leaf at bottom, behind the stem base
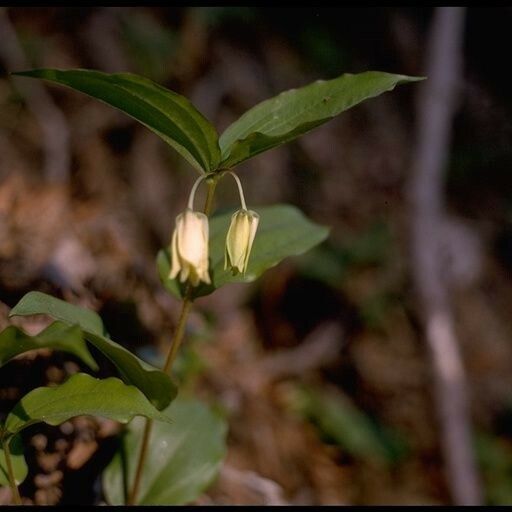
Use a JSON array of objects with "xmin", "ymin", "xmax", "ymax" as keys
[{"xmin": 103, "ymin": 397, "xmax": 227, "ymax": 505}]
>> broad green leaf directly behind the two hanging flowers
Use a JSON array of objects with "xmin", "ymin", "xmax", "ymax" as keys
[{"xmin": 157, "ymin": 204, "xmax": 329, "ymax": 297}]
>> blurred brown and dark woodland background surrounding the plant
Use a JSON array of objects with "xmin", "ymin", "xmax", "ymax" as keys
[{"xmin": 0, "ymin": 7, "xmax": 512, "ymax": 504}]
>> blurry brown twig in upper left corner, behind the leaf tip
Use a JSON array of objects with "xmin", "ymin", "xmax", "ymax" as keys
[{"xmin": 0, "ymin": 8, "xmax": 71, "ymax": 183}]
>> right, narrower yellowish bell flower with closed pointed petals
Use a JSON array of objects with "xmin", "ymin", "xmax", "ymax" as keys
[{"xmin": 224, "ymin": 208, "xmax": 260, "ymax": 275}]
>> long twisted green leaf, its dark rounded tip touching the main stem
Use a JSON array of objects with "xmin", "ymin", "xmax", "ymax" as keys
[{"xmin": 9, "ymin": 292, "xmax": 177, "ymax": 410}]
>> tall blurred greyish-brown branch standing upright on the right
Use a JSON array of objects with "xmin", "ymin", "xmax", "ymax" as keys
[{"xmin": 408, "ymin": 7, "xmax": 482, "ymax": 505}]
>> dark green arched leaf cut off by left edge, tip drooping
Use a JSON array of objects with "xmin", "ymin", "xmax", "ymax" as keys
[{"xmin": 0, "ymin": 322, "xmax": 98, "ymax": 370}]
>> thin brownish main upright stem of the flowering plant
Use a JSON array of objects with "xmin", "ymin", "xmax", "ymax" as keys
[{"xmin": 126, "ymin": 176, "xmax": 218, "ymax": 505}]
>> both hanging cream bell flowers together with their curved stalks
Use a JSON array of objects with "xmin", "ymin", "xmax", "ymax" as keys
[{"xmin": 169, "ymin": 175, "xmax": 259, "ymax": 286}]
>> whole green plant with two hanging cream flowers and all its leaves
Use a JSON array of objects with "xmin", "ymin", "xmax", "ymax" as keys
[{"xmin": 0, "ymin": 65, "xmax": 419, "ymax": 505}]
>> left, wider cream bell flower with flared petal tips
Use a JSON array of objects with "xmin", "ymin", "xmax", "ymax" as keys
[{"xmin": 169, "ymin": 208, "xmax": 211, "ymax": 286}]
